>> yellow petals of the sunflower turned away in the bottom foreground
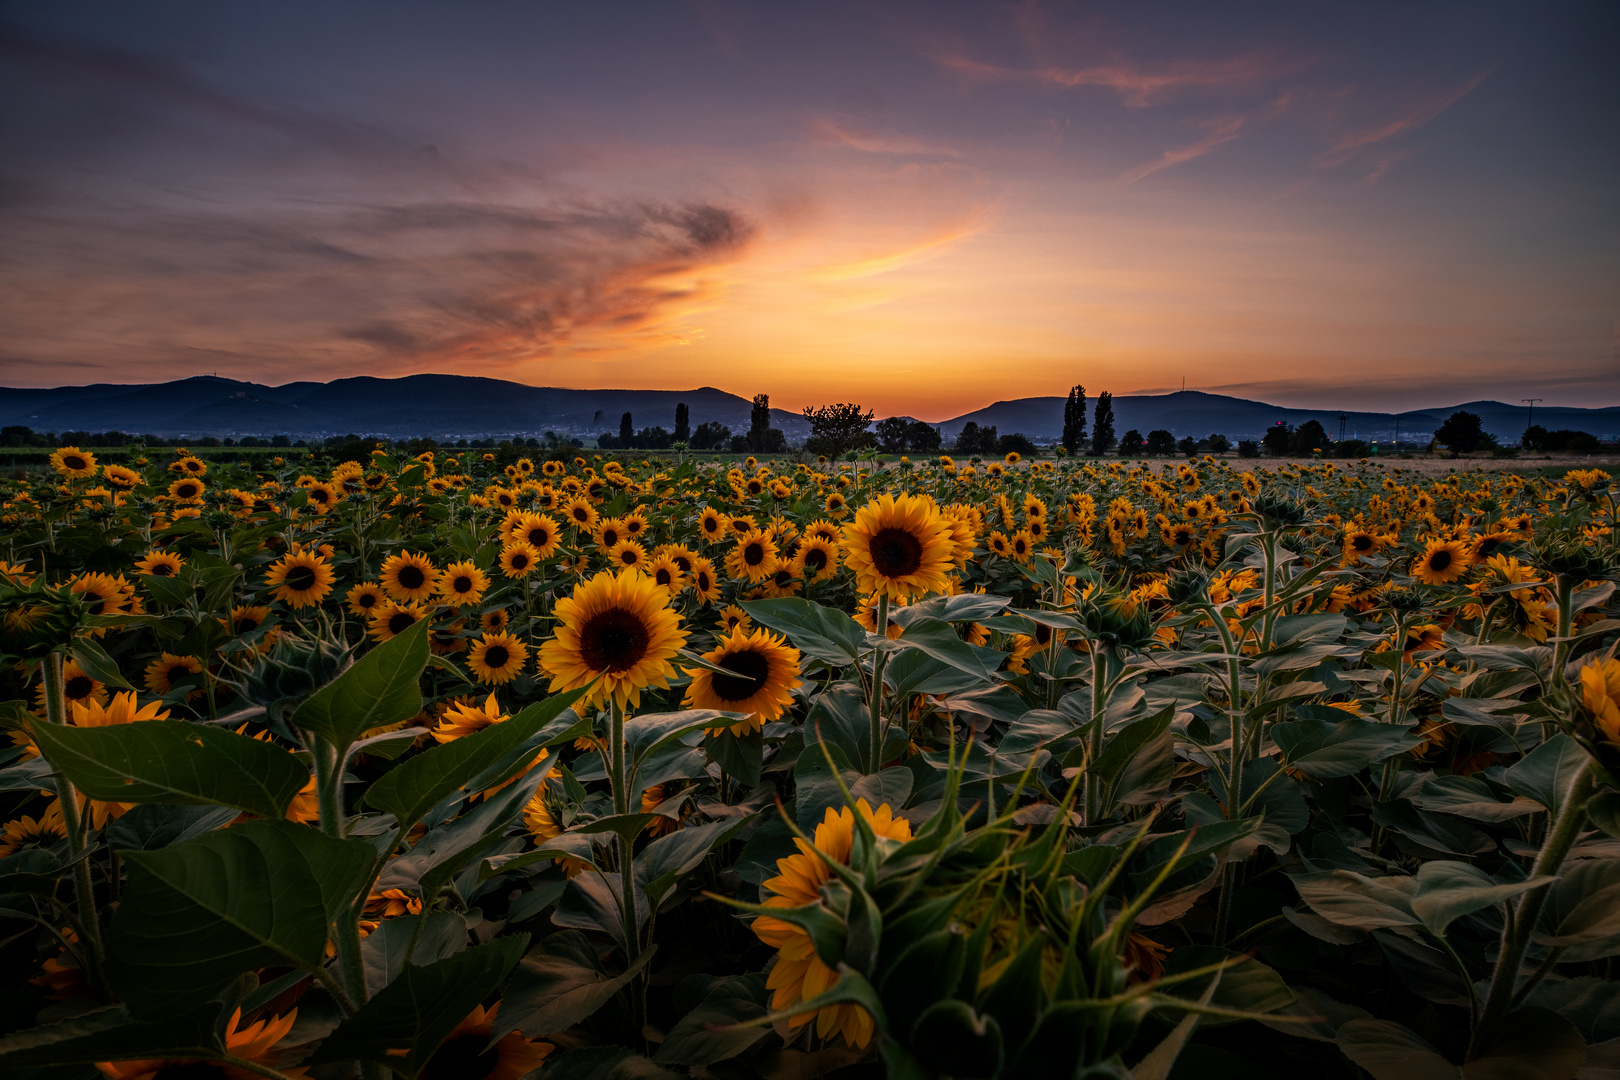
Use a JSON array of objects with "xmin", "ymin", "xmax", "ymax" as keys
[{"xmin": 753, "ymin": 798, "xmax": 910, "ymax": 1048}]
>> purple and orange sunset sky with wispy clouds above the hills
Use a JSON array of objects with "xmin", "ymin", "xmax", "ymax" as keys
[{"xmin": 0, "ymin": 0, "xmax": 1620, "ymax": 421}]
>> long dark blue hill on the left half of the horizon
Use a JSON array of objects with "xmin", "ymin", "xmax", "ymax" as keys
[{"xmin": 0, "ymin": 376, "xmax": 810, "ymax": 439}]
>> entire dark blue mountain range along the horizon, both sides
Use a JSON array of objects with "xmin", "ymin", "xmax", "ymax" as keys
[{"xmin": 0, "ymin": 374, "xmax": 1620, "ymax": 444}]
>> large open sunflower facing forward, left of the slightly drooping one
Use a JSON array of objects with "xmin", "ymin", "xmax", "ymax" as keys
[{"xmin": 539, "ymin": 570, "xmax": 687, "ymax": 708}]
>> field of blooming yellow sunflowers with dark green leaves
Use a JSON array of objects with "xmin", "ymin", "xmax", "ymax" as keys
[{"xmin": 0, "ymin": 447, "xmax": 1620, "ymax": 1080}]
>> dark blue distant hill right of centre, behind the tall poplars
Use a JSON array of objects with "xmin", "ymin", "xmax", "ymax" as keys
[{"xmin": 938, "ymin": 390, "xmax": 1620, "ymax": 442}]
